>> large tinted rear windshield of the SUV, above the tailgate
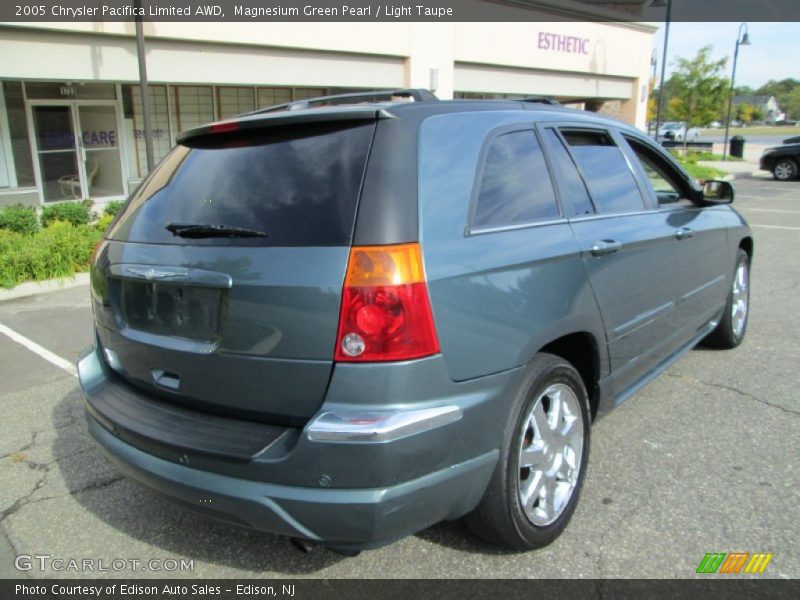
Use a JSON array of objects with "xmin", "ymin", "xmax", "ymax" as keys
[{"xmin": 108, "ymin": 123, "xmax": 374, "ymax": 246}]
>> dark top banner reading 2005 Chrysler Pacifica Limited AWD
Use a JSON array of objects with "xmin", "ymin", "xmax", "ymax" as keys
[{"xmin": 0, "ymin": 0, "xmax": 800, "ymax": 23}]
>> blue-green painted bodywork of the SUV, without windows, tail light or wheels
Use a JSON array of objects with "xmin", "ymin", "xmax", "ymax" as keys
[{"xmin": 78, "ymin": 96, "xmax": 752, "ymax": 549}]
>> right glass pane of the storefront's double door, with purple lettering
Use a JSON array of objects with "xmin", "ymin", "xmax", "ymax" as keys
[{"xmin": 78, "ymin": 104, "xmax": 125, "ymax": 200}]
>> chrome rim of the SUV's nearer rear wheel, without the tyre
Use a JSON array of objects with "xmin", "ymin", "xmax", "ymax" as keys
[{"xmin": 518, "ymin": 383, "xmax": 586, "ymax": 526}]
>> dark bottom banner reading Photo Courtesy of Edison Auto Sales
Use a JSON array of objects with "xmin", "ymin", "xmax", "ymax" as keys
[{"xmin": 0, "ymin": 576, "xmax": 800, "ymax": 600}]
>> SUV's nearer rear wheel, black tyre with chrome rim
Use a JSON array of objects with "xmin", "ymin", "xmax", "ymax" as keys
[{"xmin": 465, "ymin": 353, "xmax": 591, "ymax": 551}]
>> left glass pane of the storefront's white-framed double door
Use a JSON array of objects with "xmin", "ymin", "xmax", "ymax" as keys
[{"xmin": 31, "ymin": 104, "xmax": 84, "ymax": 202}]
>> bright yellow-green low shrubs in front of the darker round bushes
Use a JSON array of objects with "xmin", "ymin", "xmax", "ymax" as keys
[{"xmin": 0, "ymin": 221, "xmax": 102, "ymax": 287}]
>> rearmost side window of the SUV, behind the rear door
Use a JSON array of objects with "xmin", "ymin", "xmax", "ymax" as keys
[{"xmin": 471, "ymin": 130, "xmax": 560, "ymax": 229}]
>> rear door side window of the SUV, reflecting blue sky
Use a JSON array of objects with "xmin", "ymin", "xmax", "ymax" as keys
[{"xmin": 561, "ymin": 129, "xmax": 644, "ymax": 213}]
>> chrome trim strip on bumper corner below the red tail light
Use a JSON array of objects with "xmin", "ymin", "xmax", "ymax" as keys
[{"xmin": 306, "ymin": 406, "xmax": 463, "ymax": 443}]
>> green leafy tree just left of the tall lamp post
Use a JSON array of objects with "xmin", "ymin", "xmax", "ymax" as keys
[{"xmin": 669, "ymin": 46, "xmax": 730, "ymax": 128}]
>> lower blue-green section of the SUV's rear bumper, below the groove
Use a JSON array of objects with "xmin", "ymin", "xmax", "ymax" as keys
[{"xmin": 87, "ymin": 414, "xmax": 497, "ymax": 550}]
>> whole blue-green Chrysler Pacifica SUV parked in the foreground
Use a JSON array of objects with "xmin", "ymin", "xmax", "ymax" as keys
[{"xmin": 79, "ymin": 90, "xmax": 753, "ymax": 552}]
